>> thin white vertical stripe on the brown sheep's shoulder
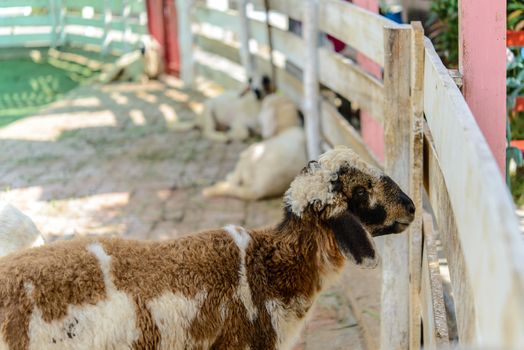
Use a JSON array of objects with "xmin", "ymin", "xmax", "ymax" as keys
[{"xmin": 224, "ymin": 225, "xmax": 258, "ymax": 321}]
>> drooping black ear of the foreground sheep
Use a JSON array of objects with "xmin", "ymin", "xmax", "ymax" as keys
[{"xmin": 329, "ymin": 212, "xmax": 380, "ymax": 268}]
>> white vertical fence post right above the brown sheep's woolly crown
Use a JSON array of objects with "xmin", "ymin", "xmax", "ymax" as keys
[{"xmin": 303, "ymin": 0, "xmax": 320, "ymax": 159}]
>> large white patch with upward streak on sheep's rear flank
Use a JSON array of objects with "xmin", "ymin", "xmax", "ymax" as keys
[{"xmin": 26, "ymin": 243, "xmax": 139, "ymax": 350}]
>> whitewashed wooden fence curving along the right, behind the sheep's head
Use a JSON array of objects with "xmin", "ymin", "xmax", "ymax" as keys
[{"xmin": 176, "ymin": 0, "xmax": 524, "ymax": 350}]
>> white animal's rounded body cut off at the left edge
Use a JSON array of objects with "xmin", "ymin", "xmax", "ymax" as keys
[{"xmin": 0, "ymin": 201, "xmax": 44, "ymax": 256}]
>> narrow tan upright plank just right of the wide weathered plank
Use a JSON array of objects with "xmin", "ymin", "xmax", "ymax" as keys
[{"xmin": 408, "ymin": 22, "xmax": 424, "ymax": 349}]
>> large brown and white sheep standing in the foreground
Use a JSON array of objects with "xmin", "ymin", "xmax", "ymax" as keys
[{"xmin": 0, "ymin": 149, "xmax": 415, "ymax": 350}]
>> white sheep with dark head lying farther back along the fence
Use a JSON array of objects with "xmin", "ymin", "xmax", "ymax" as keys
[{"xmin": 171, "ymin": 76, "xmax": 271, "ymax": 142}]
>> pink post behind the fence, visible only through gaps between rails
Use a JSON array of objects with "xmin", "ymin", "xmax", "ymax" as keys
[{"xmin": 353, "ymin": 0, "xmax": 384, "ymax": 161}]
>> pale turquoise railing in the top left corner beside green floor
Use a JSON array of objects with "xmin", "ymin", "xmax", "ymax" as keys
[{"xmin": 0, "ymin": 0, "xmax": 147, "ymax": 54}]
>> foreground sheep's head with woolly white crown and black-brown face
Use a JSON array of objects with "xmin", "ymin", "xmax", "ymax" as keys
[{"xmin": 285, "ymin": 147, "xmax": 415, "ymax": 267}]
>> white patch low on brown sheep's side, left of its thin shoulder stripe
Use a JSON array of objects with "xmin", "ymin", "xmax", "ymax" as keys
[{"xmin": 147, "ymin": 291, "xmax": 207, "ymax": 350}]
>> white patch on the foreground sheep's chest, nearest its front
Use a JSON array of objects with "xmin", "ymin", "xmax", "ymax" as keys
[{"xmin": 266, "ymin": 298, "xmax": 311, "ymax": 350}]
